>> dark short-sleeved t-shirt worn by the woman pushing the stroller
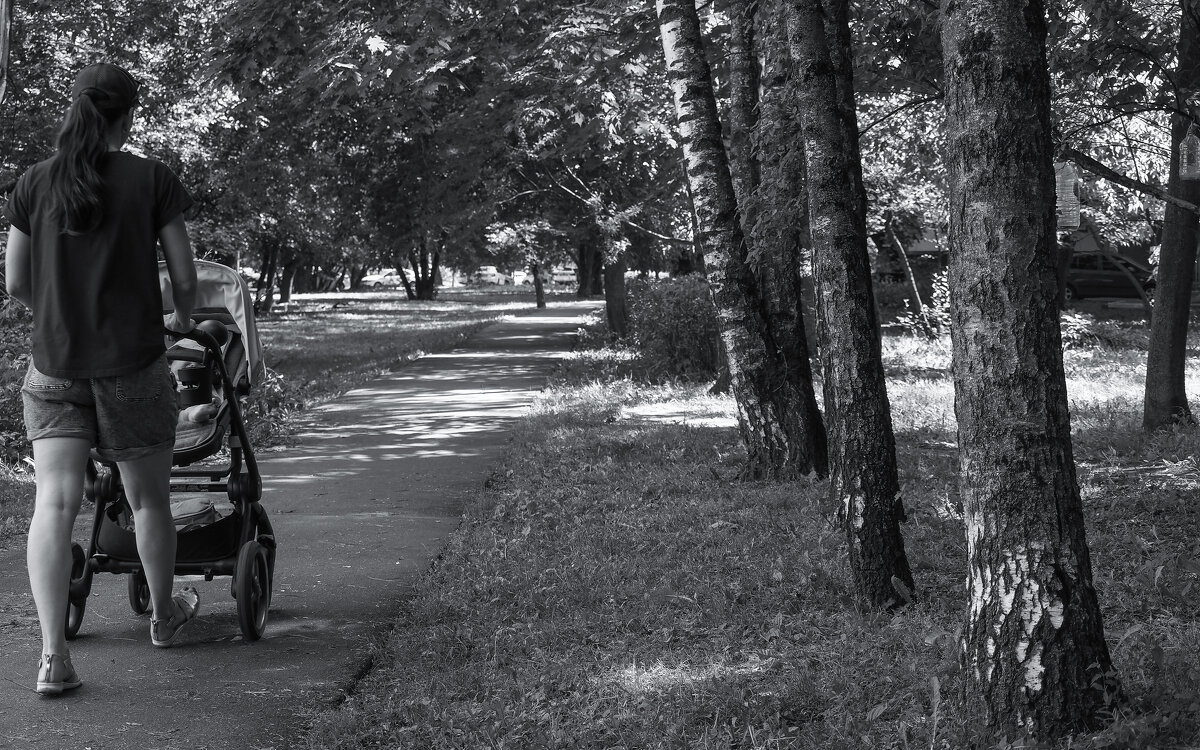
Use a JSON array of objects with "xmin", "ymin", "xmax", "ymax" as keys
[{"xmin": 5, "ymin": 151, "xmax": 192, "ymax": 378}]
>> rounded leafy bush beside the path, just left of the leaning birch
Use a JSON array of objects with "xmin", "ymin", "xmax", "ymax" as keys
[{"xmin": 628, "ymin": 274, "xmax": 721, "ymax": 379}]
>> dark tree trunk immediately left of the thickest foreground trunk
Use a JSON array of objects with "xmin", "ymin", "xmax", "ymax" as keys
[{"xmin": 788, "ymin": 0, "xmax": 913, "ymax": 606}]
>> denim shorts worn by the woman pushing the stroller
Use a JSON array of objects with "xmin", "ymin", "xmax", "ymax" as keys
[{"xmin": 20, "ymin": 355, "xmax": 179, "ymax": 461}]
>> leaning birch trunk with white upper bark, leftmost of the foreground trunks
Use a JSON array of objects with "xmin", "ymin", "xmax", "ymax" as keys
[{"xmin": 658, "ymin": 0, "xmax": 830, "ymax": 479}]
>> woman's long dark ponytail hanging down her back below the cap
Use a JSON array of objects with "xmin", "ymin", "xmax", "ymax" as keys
[{"xmin": 50, "ymin": 94, "xmax": 124, "ymax": 234}]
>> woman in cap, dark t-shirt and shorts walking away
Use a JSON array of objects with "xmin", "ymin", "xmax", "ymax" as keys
[{"xmin": 5, "ymin": 62, "xmax": 199, "ymax": 695}]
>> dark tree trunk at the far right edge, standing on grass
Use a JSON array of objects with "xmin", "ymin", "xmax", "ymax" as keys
[{"xmin": 1142, "ymin": 0, "xmax": 1200, "ymax": 430}]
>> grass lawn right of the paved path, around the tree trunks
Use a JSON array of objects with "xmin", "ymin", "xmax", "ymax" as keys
[{"xmin": 297, "ymin": 312, "xmax": 1200, "ymax": 750}]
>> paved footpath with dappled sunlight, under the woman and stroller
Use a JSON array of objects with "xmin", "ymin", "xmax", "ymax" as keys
[{"xmin": 0, "ymin": 302, "xmax": 596, "ymax": 750}]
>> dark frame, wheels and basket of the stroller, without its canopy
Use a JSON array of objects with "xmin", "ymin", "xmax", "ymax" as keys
[{"xmin": 65, "ymin": 264, "xmax": 276, "ymax": 641}]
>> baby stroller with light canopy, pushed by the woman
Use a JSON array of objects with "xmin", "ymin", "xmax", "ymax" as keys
[{"xmin": 66, "ymin": 260, "xmax": 275, "ymax": 641}]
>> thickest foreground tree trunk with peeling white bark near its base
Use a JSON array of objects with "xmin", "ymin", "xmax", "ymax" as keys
[{"xmin": 942, "ymin": 0, "xmax": 1115, "ymax": 737}]
